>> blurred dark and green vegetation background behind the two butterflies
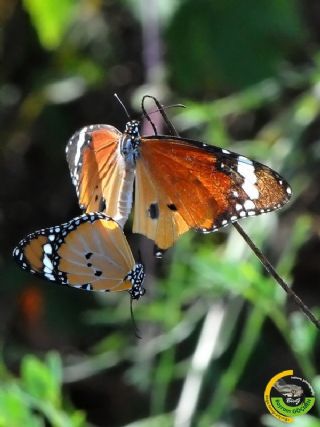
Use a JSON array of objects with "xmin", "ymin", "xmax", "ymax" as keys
[{"xmin": 0, "ymin": 0, "xmax": 320, "ymax": 427}]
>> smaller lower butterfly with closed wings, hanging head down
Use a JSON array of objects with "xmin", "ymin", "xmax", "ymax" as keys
[{"xmin": 13, "ymin": 212, "xmax": 145, "ymax": 299}]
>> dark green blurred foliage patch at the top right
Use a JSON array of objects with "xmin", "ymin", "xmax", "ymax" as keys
[{"xmin": 168, "ymin": 0, "xmax": 304, "ymax": 96}]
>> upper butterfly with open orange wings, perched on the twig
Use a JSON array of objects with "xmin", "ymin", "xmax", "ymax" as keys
[{"xmin": 66, "ymin": 108, "xmax": 291, "ymax": 253}]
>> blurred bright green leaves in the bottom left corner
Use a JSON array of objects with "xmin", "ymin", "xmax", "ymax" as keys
[{"xmin": 0, "ymin": 353, "xmax": 87, "ymax": 427}]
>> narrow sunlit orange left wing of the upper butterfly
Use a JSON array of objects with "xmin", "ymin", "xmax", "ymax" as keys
[{"xmin": 66, "ymin": 125, "xmax": 134, "ymax": 226}]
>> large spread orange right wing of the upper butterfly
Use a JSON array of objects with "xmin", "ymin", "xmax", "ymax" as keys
[{"xmin": 133, "ymin": 136, "xmax": 291, "ymax": 249}]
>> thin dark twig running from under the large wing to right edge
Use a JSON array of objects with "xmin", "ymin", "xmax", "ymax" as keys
[{"xmin": 233, "ymin": 222, "xmax": 320, "ymax": 329}]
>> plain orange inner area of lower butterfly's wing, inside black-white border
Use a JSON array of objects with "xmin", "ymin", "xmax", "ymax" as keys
[{"xmin": 57, "ymin": 214, "xmax": 135, "ymax": 291}]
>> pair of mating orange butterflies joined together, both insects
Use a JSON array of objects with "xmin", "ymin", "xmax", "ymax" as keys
[{"xmin": 13, "ymin": 100, "xmax": 291, "ymax": 299}]
